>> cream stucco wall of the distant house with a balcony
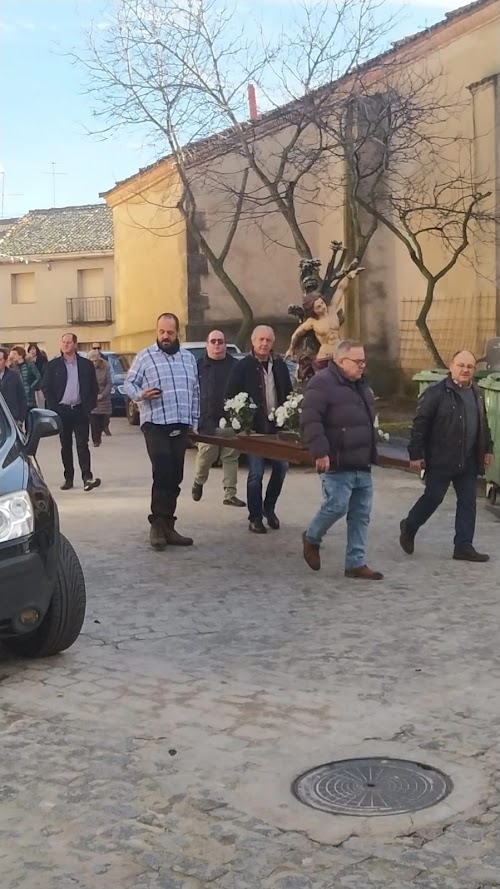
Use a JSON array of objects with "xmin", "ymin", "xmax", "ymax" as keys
[{"xmin": 0, "ymin": 254, "xmax": 115, "ymax": 356}]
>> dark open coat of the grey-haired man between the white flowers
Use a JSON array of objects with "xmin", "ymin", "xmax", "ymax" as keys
[{"xmin": 226, "ymin": 354, "xmax": 292, "ymax": 434}]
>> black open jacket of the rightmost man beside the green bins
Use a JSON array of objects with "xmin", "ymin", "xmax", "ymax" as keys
[{"xmin": 408, "ymin": 376, "xmax": 493, "ymax": 476}]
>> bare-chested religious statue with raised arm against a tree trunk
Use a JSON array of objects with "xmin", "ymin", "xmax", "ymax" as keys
[{"xmin": 285, "ymin": 241, "xmax": 364, "ymax": 363}]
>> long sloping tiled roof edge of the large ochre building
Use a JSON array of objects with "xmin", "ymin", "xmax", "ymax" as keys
[{"xmin": 100, "ymin": 0, "xmax": 498, "ymax": 197}]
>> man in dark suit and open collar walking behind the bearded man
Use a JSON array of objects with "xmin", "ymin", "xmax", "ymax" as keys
[{"xmin": 42, "ymin": 333, "xmax": 101, "ymax": 491}]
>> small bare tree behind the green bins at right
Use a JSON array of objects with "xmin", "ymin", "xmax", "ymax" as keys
[{"xmin": 343, "ymin": 66, "xmax": 497, "ymax": 367}]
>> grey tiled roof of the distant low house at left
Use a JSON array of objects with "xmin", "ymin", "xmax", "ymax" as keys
[{"xmin": 0, "ymin": 204, "xmax": 113, "ymax": 259}]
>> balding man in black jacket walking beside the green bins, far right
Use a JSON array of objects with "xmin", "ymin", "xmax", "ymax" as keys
[{"xmin": 399, "ymin": 349, "xmax": 493, "ymax": 562}]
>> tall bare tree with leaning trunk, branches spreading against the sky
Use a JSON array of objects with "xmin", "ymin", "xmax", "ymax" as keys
[{"xmin": 78, "ymin": 0, "xmax": 400, "ymax": 343}]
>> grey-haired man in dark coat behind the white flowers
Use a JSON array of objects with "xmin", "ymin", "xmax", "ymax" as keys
[{"xmin": 226, "ymin": 325, "xmax": 292, "ymax": 534}]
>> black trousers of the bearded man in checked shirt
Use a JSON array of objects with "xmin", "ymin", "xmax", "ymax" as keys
[{"xmin": 142, "ymin": 423, "xmax": 188, "ymax": 522}]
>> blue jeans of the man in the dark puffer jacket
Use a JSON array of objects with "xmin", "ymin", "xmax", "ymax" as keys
[{"xmin": 306, "ymin": 470, "xmax": 373, "ymax": 569}]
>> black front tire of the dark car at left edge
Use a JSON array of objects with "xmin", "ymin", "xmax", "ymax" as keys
[{"xmin": 4, "ymin": 535, "xmax": 86, "ymax": 658}]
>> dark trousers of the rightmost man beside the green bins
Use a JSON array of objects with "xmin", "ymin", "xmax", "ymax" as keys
[{"xmin": 406, "ymin": 457, "xmax": 478, "ymax": 550}]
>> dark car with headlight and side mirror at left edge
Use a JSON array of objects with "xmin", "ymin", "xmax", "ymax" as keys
[{"xmin": 0, "ymin": 396, "xmax": 86, "ymax": 658}]
